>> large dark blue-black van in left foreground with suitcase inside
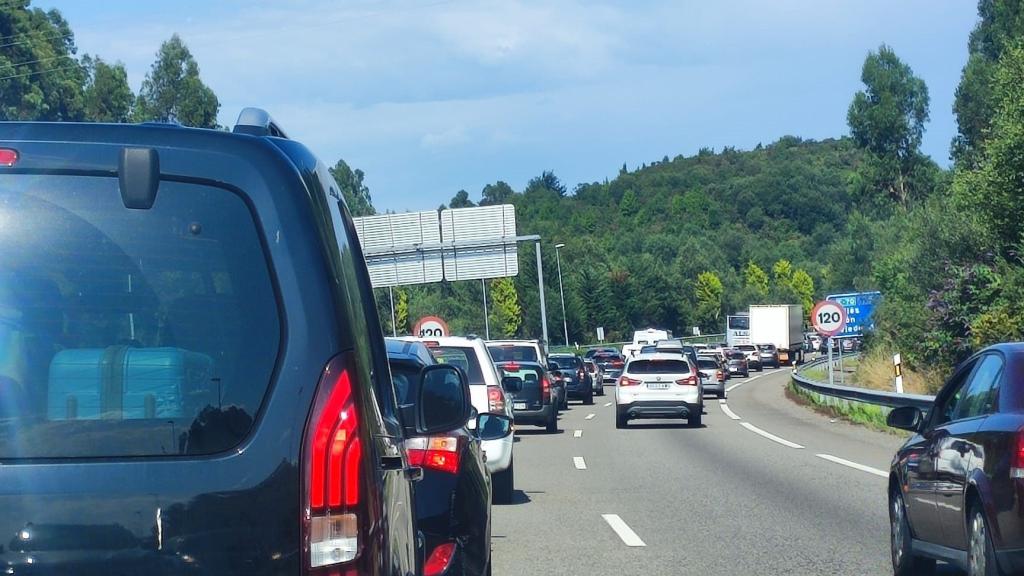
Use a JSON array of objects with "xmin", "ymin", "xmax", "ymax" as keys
[{"xmin": 0, "ymin": 109, "xmax": 471, "ymax": 575}]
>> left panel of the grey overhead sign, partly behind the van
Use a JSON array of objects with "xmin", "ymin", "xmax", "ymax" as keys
[{"xmin": 353, "ymin": 210, "xmax": 443, "ymax": 288}]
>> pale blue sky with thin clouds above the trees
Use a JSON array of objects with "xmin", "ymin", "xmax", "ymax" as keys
[{"xmin": 46, "ymin": 0, "xmax": 977, "ymax": 211}]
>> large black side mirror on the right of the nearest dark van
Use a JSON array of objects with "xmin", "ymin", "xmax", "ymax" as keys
[{"xmin": 416, "ymin": 364, "xmax": 473, "ymax": 436}]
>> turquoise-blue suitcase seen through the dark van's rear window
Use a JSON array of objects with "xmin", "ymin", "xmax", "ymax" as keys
[{"xmin": 46, "ymin": 346, "xmax": 219, "ymax": 420}]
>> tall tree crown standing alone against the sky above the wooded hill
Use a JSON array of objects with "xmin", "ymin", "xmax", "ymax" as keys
[{"xmin": 847, "ymin": 44, "xmax": 929, "ymax": 206}]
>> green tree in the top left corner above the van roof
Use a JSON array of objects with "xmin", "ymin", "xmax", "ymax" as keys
[{"xmin": 0, "ymin": 1, "xmax": 86, "ymax": 121}]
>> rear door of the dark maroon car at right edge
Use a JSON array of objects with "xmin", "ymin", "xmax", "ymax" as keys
[{"xmin": 930, "ymin": 353, "xmax": 1002, "ymax": 550}]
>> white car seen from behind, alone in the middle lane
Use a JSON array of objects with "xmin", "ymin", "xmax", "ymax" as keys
[{"xmin": 615, "ymin": 353, "xmax": 703, "ymax": 428}]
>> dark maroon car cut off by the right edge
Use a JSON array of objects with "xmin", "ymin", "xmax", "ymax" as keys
[{"xmin": 888, "ymin": 342, "xmax": 1024, "ymax": 576}]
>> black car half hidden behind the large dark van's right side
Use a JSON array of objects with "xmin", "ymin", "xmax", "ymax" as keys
[{"xmin": 386, "ymin": 338, "xmax": 512, "ymax": 576}]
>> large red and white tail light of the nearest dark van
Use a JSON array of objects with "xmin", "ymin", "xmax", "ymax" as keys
[{"xmin": 302, "ymin": 354, "xmax": 370, "ymax": 574}]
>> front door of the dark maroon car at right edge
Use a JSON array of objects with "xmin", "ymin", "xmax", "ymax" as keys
[{"xmin": 904, "ymin": 359, "xmax": 976, "ymax": 544}]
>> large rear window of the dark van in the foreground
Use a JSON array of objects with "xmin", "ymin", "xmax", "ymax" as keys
[{"xmin": 0, "ymin": 174, "xmax": 281, "ymax": 459}]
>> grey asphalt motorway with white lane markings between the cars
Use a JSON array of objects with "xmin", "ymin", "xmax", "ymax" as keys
[{"xmin": 493, "ymin": 370, "xmax": 956, "ymax": 576}]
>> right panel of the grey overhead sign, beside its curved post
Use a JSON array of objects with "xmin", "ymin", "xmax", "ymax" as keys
[{"xmin": 440, "ymin": 204, "xmax": 519, "ymax": 282}]
